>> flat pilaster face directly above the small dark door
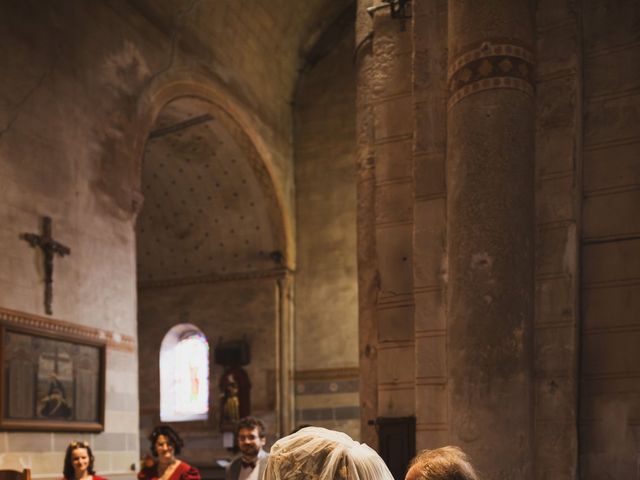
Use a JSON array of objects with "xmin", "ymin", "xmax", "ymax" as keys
[{"xmin": 372, "ymin": 5, "xmax": 415, "ymax": 426}]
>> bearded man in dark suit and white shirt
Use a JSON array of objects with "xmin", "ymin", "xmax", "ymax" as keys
[{"xmin": 226, "ymin": 417, "xmax": 269, "ymax": 480}]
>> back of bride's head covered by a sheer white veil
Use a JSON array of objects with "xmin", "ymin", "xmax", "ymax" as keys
[{"xmin": 263, "ymin": 427, "xmax": 393, "ymax": 480}]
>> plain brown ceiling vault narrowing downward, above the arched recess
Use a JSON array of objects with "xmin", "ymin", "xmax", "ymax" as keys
[{"xmin": 129, "ymin": 0, "xmax": 354, "ymax": 123}]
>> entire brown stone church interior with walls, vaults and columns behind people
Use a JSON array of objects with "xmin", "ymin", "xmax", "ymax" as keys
[{"xmin": 0, "ymin": 0, "xmax": 640, "ymax": 480}]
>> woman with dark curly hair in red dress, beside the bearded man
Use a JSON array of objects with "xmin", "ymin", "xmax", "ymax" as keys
[{"xmin": 138, "ymin": 425, "xmax": 200, "ymax": 480}]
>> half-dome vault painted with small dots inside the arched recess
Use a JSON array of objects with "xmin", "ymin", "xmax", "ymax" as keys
[{"xmin": 136, "ymin": 99, "xmax": 283, "ymax": 282}]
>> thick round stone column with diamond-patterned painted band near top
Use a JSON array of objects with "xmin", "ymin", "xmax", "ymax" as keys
[{"xmin": 447, "ymin": 0, "xmax": 534, "ymax": 480}]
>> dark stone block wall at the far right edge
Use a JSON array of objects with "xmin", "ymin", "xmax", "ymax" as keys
[{"xmin": 579, "ymin": 1, "xmax": 640, "ymax": 478}]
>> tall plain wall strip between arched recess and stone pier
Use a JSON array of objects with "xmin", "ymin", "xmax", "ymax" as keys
[{"xmin": 294, "ymin": 3, "xmax": 360, "ymax": 438}]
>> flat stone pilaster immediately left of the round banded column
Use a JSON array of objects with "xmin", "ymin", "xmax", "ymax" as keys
[{"xmin": 412, "ymin": 0, "xmax": 449, "ymax": 450}]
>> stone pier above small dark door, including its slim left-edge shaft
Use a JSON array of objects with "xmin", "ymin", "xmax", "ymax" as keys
[{"xmin": 356, "ymin": 1, "xmax": 415, "ymax": 444}]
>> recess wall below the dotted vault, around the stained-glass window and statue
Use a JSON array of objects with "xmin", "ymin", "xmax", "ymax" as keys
[{"xmin": 138, "ymin": 278, "xmax": 277, "ymax": 465}]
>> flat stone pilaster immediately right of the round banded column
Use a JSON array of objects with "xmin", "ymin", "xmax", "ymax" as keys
[{"xmin": 533, "ymin": 2, "xmax": 583, "ymax": 480}]
